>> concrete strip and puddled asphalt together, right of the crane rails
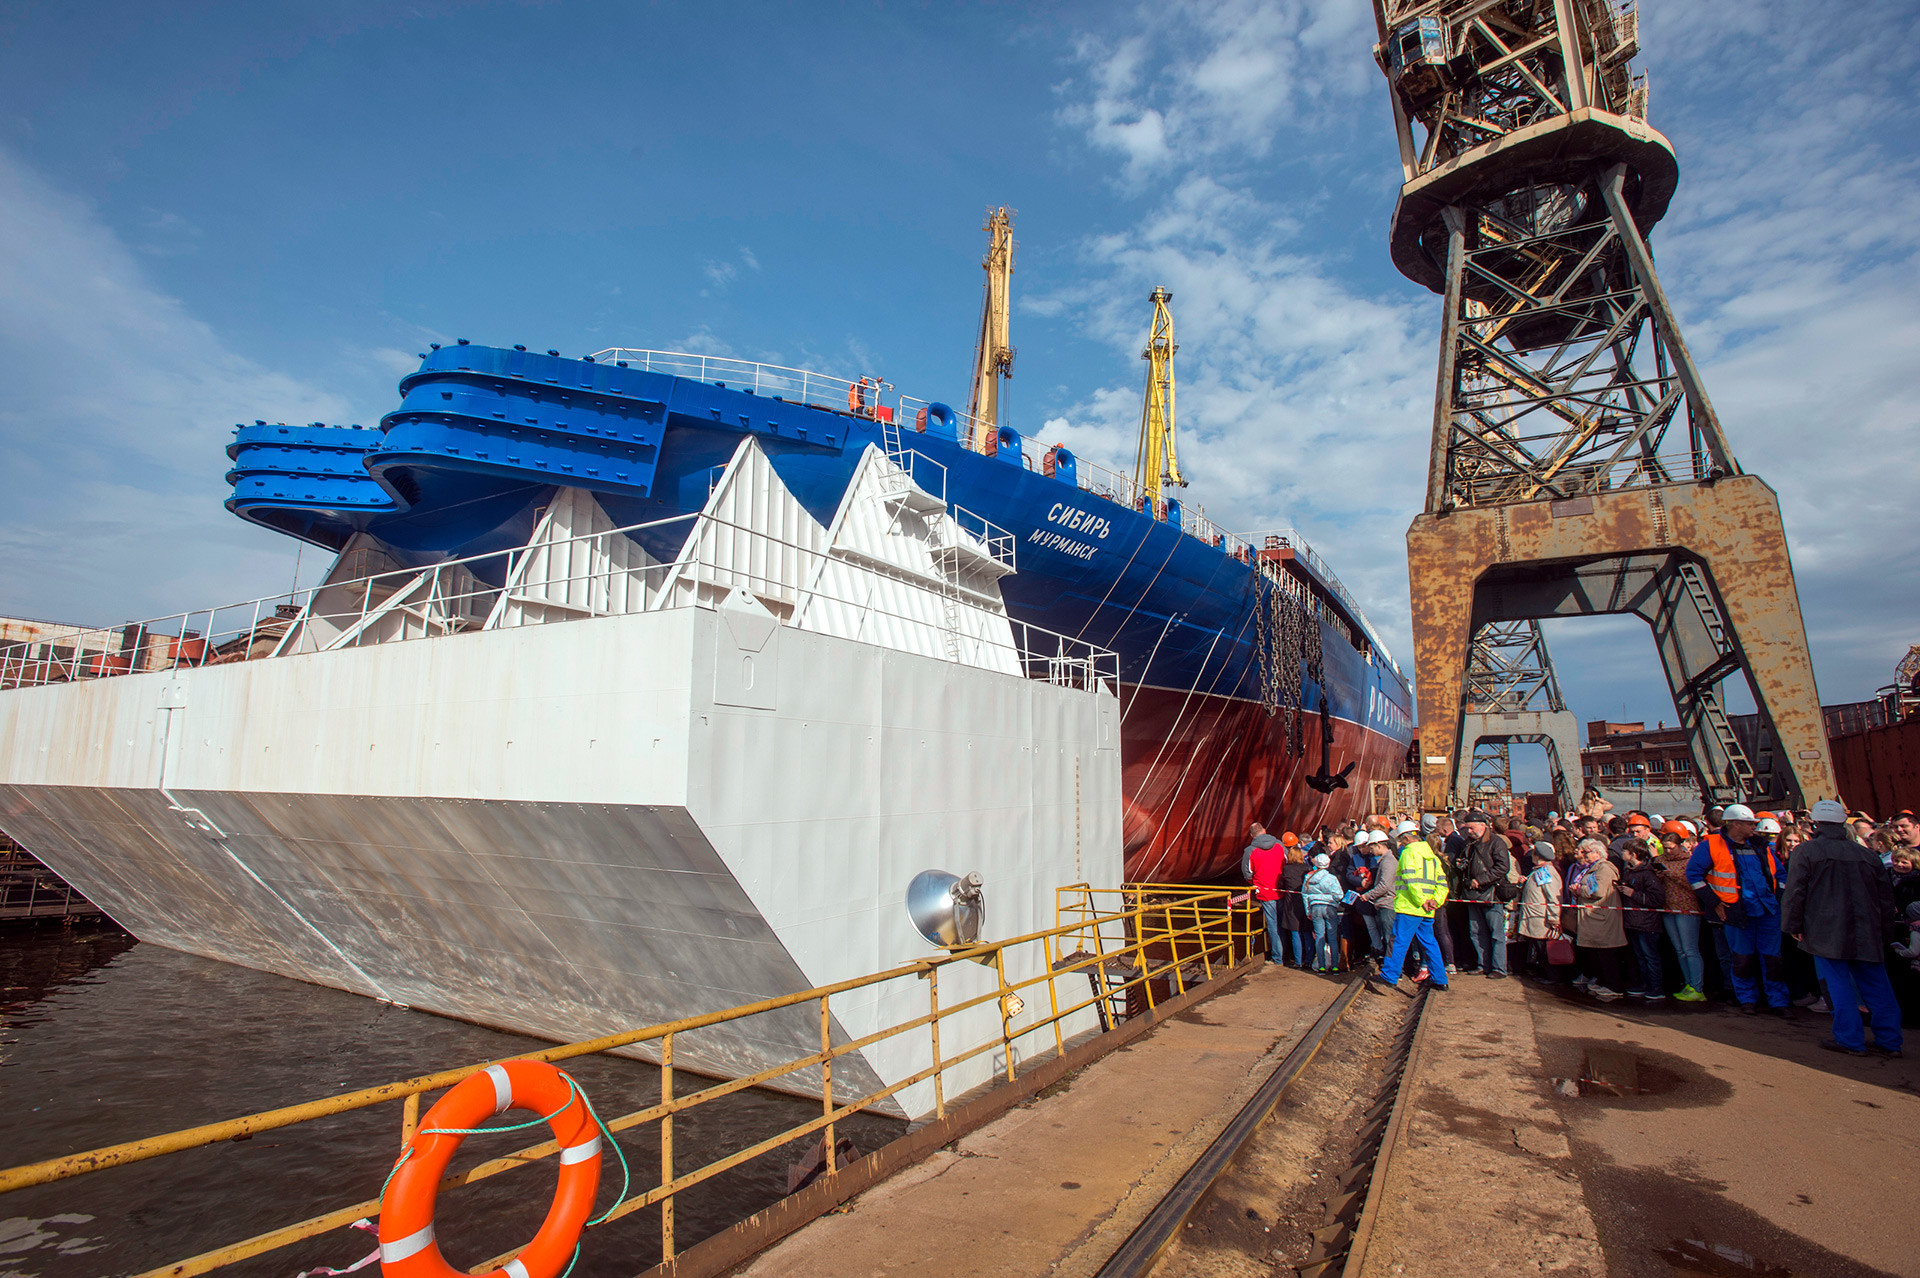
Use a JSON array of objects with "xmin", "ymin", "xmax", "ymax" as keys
[{"xmin": 1363, "ymin": 975, "xmax": 1920, "ymax": 1278}]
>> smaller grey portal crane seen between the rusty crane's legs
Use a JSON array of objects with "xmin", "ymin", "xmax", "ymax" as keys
[{"xmin": 1453, "ymin": 618, "xmax": 1580, "ymax": 812}]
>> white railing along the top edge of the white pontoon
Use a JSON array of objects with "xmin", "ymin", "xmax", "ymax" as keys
[{"xmin": 0, "ymin": 514, "xmax": 1119, "ymax": 691}]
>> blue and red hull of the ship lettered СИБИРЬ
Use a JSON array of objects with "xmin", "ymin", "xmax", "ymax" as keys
[{"xmin": 227, "ymin": 343, "xmax": 1413, "ymax": 879}]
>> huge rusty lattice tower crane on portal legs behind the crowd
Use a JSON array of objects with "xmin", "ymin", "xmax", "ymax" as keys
[{"xmin": 1375, "ymin": 0, "xmax": 1836, "ymax": 808}]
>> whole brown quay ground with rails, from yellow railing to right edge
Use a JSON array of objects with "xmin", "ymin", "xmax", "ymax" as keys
[{"xmin": 743, "ymin": 969, "xmax": 1920, "ymax": 1278}]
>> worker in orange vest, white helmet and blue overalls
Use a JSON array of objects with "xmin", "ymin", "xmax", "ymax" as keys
[{"xmin": 1686, "ymin": 804, "xmax": 1793, "ymax": 1019}]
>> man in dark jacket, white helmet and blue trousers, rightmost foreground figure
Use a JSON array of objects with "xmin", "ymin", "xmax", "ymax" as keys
[{"xmin": 1780, "ymin": 798, "xmax": 1901, "ymax": 1055}]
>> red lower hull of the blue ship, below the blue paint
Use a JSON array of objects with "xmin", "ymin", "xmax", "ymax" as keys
[{"xmin": 1119, "ymin": 685, "xmax": 1407, "ymax": 883}]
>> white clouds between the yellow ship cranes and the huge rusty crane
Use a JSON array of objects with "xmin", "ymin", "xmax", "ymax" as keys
[{"xmin": 1025, "ymin": 4, "xmax": 1434, "ymax": 666}]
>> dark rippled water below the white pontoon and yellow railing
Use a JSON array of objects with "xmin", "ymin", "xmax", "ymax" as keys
[{"xmin": 0, "ymin": 927, "xmax": 904, "ymax": 1278}]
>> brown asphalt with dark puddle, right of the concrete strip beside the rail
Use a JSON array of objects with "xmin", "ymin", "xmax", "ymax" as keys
[{"xmin": 1528, "ymin": 988, "xmax": 1920, "ymax": 1278}]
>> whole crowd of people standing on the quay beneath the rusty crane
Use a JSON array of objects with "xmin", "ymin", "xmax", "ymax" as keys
[{"xmin": 1240, "ymin": 794, "xmax": 1920, "ymax": 1055}]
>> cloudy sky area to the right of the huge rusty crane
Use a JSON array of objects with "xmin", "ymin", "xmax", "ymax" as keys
[{"xmin": 1642, "ymin": 0, "xmax": 1920, "ymax": 702}]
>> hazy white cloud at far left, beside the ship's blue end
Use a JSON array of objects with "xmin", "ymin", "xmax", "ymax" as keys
[{"xmin": 0, "ymin": 152, "xmax": 349, "ymax": 624}]
